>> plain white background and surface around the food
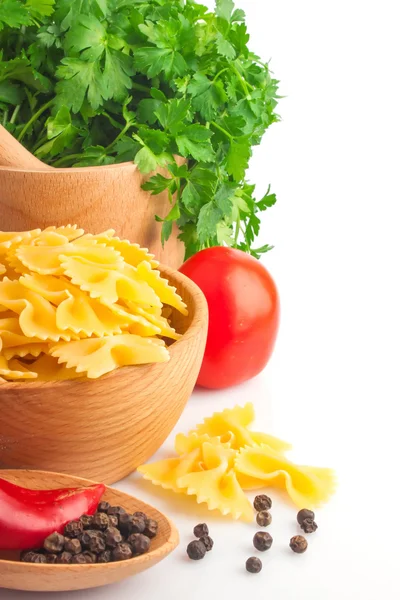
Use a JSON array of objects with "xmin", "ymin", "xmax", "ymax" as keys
[{"xmin": 0, "ymin": 0, "xmax": 400, "ymax": 600}]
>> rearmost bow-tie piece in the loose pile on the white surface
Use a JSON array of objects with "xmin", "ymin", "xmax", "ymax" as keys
[{"xmin": 195, "ymin": 402, "xmax": 291, "ymax": 452}]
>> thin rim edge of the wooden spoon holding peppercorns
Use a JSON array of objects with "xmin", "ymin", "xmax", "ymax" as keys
[{"xmin": 0, "ymin": 469, "xmax": 179, "ymax": 568}]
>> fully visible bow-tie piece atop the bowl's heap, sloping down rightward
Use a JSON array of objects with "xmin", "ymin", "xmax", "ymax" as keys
[{"xmin": 62, "ymin": 256, "xmax": 162, "ymax": 307}]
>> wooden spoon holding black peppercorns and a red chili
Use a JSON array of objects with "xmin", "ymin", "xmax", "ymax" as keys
[{"xmin": 0, "ymin": 470, "xmax": 179, "ymax": 596}]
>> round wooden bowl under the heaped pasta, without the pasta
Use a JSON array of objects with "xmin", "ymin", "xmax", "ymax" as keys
[{"xmin": 0, "ymin": 267, "xmax": 208, "ymax": 483}]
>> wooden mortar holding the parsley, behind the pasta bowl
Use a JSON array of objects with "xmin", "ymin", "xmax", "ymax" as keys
[{"xmin": 0, "ymin": 163, "xmax": 185, "ymax": 269}]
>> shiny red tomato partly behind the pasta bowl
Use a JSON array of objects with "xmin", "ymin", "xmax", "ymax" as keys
[{"xmin": 180, "ymin": 247, "xmax": 279, "ymax": 388}]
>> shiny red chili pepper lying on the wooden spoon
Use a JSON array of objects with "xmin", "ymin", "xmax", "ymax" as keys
[{"xmin": 0, "ymin": 479, "xmax": 105, "ymax": 550}]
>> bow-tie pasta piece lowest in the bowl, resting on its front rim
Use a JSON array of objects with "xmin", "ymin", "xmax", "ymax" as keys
[{"xmin": 50, "ymin": 333, "xmax": 169, "ymax": 379}]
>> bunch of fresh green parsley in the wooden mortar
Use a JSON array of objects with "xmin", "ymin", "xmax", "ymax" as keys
[{"xmin": 0, "ymin": 0, "xmax": 278, "ymax": 257}]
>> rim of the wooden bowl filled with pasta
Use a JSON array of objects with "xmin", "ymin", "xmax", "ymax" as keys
[{"xmin": 0, "ymin": 264, "xmax": 208, "ymax": 390}]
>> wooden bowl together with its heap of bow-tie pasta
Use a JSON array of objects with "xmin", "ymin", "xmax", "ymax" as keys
[{"xmin": 0, "ymin": 226, "xmax": 208, "ymax": 483}]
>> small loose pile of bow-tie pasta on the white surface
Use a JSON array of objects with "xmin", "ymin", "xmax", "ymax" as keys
[{"xmin": 138, "ymin": 403, "xmax": 336, "ymax": 520}]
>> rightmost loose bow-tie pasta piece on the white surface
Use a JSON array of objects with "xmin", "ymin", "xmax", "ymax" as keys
[{"xmin": 235, "ymin": 446, "xmax": 336, "ymax": 507}]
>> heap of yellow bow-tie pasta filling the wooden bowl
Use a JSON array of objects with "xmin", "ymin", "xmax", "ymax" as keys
[{"xmin": 0, "ymin": 225, "xmax": 187, "ymax": 383}]
